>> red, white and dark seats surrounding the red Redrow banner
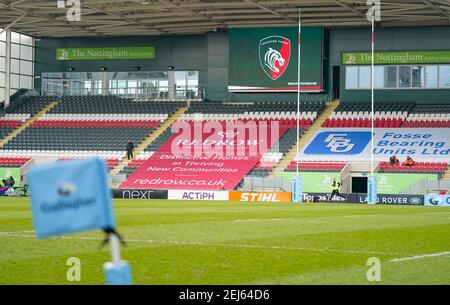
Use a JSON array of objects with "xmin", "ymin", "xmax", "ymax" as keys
[{"xmin": 114, "ymin": 101, "xmax": 326, "ymax": 184}]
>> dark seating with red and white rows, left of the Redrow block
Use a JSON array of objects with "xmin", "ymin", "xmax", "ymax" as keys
[{"xmin": 0, "ymin": 96, "xmax": 184, "ymax": 168}]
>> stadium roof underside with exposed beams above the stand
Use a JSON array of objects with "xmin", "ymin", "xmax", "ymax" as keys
[{"xmin": 0, "ymin": 0, "xmax": 450, "ymax": 37}]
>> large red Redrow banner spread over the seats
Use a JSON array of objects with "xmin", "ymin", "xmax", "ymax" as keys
[{"xmin": 120, "ymin": 121, "xmax": 287, "ymax": 190}]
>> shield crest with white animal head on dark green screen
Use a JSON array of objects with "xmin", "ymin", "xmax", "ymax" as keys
[{"xmin": 259, "ymin": 36, "xmax": 291, "ymax": 80}]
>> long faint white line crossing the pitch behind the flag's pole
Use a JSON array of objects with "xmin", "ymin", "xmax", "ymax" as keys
[{"xmin": 0, "ymin": 232, "xmax": 408, "ymax": 255}]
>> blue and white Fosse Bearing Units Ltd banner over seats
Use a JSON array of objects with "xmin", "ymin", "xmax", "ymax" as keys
[{"xmin": 297, "ymin": 128, "xmax": 450, "ymax": 162}]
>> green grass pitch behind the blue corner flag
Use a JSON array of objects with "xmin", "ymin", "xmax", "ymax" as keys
[{"xmin": 0, "ymin": 198, "xmax": 450, "ymax": 285}]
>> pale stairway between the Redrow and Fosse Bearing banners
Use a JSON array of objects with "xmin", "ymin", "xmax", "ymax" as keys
[{"xmin": 269, "ymin": 99, "xmax": 339, "ymax": 177}]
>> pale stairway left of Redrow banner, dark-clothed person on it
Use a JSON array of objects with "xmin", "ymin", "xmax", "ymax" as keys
[{"xmin": 109, "ymin": 107, "xmax": 188, "ymax": 177}]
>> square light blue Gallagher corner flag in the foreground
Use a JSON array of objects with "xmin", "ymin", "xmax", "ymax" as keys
[{"xmin": 28, "ymin": 158, "xmax": 116, "ymax": 238}]
